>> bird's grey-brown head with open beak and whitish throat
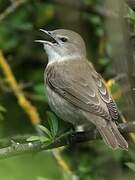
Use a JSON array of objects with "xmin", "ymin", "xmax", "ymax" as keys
[{"xmin": 36, "ymin": 29, "xmax": 86, "ymax": 63}]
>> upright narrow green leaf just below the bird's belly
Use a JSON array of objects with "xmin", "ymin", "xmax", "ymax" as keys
[{"xmin": 47, "ymin": 111, "xmax": 58, "ymax": 137}]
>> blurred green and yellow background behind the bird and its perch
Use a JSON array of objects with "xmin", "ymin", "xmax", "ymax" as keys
[{"xmin": 0, "ymin": 0, "xmax": 135, "ymax": 180}]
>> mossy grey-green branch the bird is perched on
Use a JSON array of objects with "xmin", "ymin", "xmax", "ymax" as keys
[{"xmin": 0, "ymin": 122, "xmax": 135, "ymax": 159}]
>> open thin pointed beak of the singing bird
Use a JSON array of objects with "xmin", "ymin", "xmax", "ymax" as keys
[{"xmin": 35, "ymin": 29, "xmax": 58, "ymax": 45}]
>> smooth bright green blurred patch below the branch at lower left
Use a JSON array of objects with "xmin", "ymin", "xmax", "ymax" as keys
[{"xmin": 0, "ymin": 152, "xmax": 62, "ymax": 180}]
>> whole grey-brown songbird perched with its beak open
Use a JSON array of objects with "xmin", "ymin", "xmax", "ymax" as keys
[{"xmin": 36, "ymin": 29, "xmax": 128, "ymax": 150}]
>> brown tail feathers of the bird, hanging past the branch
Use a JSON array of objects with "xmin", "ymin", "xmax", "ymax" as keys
[{"xmin": 97, "ymin": 122, "xmax": 128, "ymax": 150}]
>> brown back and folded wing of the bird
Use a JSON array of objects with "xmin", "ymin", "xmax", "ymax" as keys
[{"xmin": 46, "ymin": 60, "xmax": 117, "ymax": 120}]
